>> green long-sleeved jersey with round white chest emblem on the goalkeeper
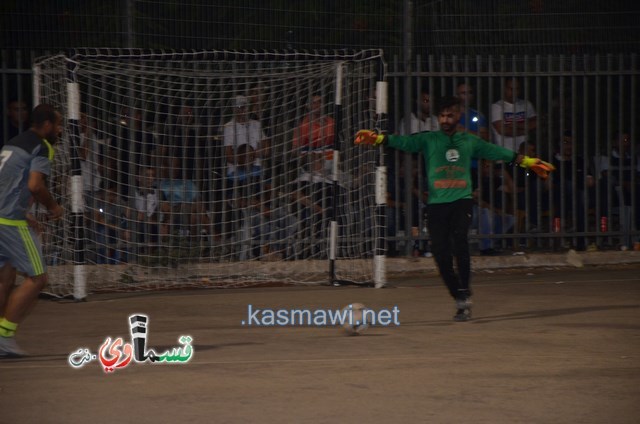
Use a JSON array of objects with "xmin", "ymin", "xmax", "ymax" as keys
[{"xmin": 387, "ymin": 131, "xmax": 517, "ymax": 204}]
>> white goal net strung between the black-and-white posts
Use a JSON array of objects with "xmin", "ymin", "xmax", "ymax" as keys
[{"xmin": 34, "ymin": 49, "xmax": 384, "ymax": 295}]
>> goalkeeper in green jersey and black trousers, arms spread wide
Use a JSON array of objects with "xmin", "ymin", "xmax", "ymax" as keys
[{"xmin": 355, "ymin": 97, "xmax": 554, "ymax": 321}]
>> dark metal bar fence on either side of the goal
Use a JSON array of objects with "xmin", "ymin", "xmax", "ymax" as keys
[{"xmin": 0, "ymin": 51, "xmax": 640, "ymax": 254}]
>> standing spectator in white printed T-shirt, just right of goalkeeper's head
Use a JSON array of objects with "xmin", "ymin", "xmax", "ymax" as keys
[{"xmin": 491, "ymin": 78, "xmax": 538, "ymax": 150}]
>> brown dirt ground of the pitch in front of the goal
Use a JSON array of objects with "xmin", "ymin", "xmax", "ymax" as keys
[{"xmin": 0, "ymin": 265, "xmax": 640, "ymax": 424}]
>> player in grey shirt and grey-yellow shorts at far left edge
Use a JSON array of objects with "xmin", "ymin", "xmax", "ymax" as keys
[{"xmin": 0, "ymin": 104, "xmax": 63, "ymax": 358}]
